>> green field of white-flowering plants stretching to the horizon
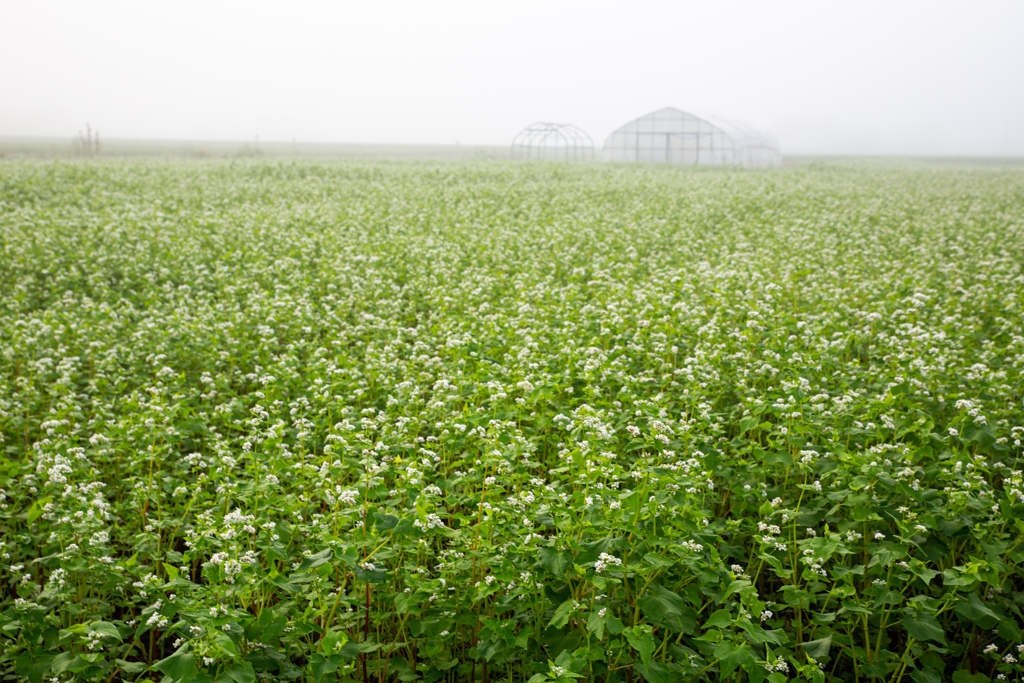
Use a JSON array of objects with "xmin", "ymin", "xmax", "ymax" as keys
[{"xmin": 0, "ymin": 162, "xmax": 1024, "ymax": 683}]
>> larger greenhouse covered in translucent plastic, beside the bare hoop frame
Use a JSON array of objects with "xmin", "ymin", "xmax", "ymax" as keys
[{"xmin": 601, "ymin": 106, "xmax": 782, "ymax": 168}]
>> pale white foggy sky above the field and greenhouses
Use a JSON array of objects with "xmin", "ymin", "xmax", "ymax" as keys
[{"xmin": 0, "ymin": 0, "xmax": 1024, "ymax": 156}]
